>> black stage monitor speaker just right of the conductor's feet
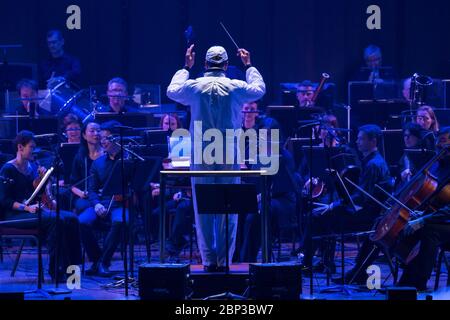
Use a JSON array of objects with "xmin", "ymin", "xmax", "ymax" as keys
[{"xmin": 250, "ymin": 263, "xmax": 302, "ymax": 300}]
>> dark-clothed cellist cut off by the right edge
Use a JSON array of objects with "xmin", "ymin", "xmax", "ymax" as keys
[{"xmin": 399, "ymin": 127, "xmax": 450, "ymax": 291}]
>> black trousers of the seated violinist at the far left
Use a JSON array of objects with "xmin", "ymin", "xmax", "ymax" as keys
[{"xmin": 6, "ymin": 209, "xmax": 81, "ymax": 277}]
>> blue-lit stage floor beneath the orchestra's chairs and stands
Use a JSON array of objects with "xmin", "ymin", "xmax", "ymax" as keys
[{"xmin": 0, "ymin": 242, "xmax": 450, "ymax": 300}]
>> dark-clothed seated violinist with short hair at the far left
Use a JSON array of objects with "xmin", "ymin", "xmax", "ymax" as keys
[{"xmin": 0, "ymin": 131, "xmax": 81, "ymax": 281}]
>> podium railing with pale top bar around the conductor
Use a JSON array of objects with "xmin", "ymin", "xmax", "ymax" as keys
[{"xmin": 159, "ymin": 170, "xmax": 269, "ymax": 263}]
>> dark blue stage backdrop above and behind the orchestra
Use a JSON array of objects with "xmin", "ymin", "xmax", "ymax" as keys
[{"xmin": 0, "ymin": 0, "xmax": 450, "ymax": 104}]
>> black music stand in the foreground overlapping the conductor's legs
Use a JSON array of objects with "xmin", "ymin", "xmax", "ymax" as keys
[{"xmin": 195, "ymin": 184, "xmax": 258, "ymax": 300}]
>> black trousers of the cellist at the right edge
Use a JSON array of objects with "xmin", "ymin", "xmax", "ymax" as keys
[{"xmin": 399, "ymin": 224, "xmax": 450, "ymax": 290}]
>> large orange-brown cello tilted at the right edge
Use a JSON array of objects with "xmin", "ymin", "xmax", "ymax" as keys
[{"xmin": 370, "ymin": 148, "xmax": 450, "ymax": 264}]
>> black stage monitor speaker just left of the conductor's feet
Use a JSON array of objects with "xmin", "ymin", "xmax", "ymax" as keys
[{"xmin": 139, "ymin": 264, "xmax": 190, "ymax": 301}]
